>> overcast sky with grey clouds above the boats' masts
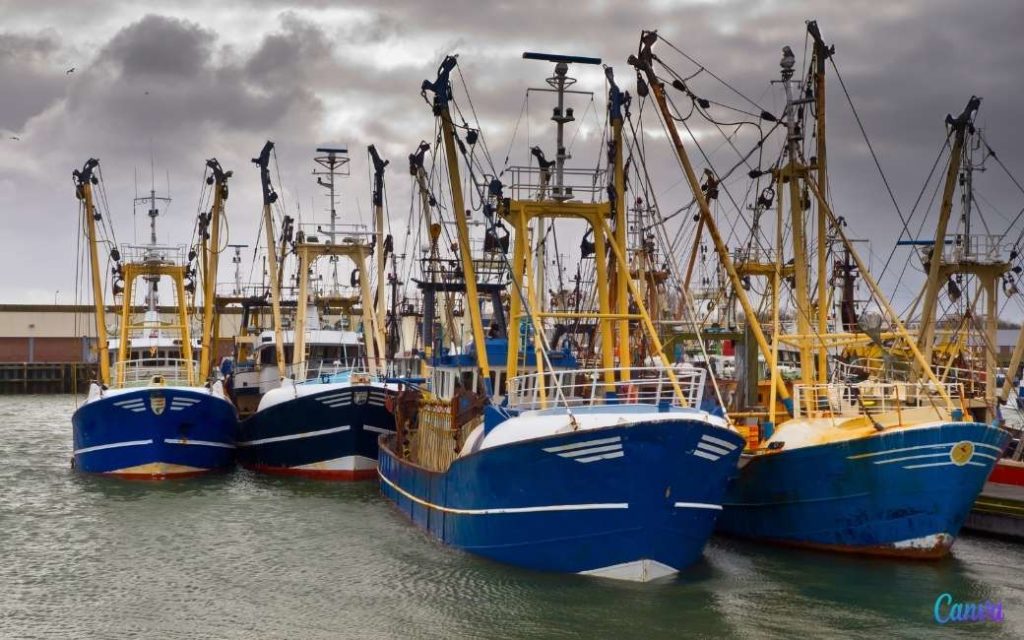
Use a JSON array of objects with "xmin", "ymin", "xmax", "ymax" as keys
[{"xmin": 0, "ymin": 0, "xmax": 1024, "ymax": 319}]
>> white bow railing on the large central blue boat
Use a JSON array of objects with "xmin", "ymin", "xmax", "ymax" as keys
[{"xmin": 507, "ymin": 367, "xmax": 707, "ymax": 411}]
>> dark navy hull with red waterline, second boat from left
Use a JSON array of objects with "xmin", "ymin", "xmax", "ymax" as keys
[{"xmin": 239, "ymin": 385, "xmax": 395, "ymax": 480}]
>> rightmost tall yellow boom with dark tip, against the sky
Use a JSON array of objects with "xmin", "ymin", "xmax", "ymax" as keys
[{"xmin": 918, "ymin": 96, "xmax": 981, "ymax": 362}]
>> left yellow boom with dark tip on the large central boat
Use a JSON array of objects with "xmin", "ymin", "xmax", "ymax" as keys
[{"xmin": 422, "ymin": 55, "xmax": 490, "ymax": 378}]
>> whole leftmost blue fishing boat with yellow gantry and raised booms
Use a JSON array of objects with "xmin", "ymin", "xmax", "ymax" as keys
[{"xmin": 72, "ymin": 159, "xmax": 238, "ymax": 478}]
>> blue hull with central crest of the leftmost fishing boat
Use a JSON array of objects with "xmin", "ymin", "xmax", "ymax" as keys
[{"xmin": 72, "ymin": 387, "xmax": 238, "ymax": 477}]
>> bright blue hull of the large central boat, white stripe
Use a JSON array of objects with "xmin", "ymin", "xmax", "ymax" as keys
[{"xmin": 380, "ymin": 418, "xmax": 743, "ymax": 580}]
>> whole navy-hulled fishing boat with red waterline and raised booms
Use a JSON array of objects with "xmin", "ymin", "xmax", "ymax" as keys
[{"xmin": 238, "ymin": 141, "xmax": 398, "ymax": 480}]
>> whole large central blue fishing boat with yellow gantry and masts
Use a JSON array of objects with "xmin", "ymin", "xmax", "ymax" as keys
[{"xmin": 379, "ymin": 53, "xmax": 743, "ymax": 581}]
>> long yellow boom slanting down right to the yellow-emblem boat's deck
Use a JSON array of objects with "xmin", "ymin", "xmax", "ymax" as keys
[{"xmin": 629, "ymin": 31, "xmax": 790, "ymax": 401}]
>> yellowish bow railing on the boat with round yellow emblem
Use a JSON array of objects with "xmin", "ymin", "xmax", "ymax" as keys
[{"xmin": 793, "ymin": 381, "xmax": 964, "ymax": 418}]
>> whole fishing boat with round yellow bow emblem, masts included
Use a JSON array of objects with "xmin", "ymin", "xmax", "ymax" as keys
[{"xmin": 630, "ymin": 23, "xmax": 1008, "ymax": 557}]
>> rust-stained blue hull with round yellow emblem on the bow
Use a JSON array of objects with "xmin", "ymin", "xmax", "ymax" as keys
[{"xmin": 718, "ymin": 423, "xmax": 1009, "ymax": 557}]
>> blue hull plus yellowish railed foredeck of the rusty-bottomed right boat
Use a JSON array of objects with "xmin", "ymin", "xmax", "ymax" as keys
[{"xmin": 719, "ymin": 383, "xmax": 1010, "ymax": 557}]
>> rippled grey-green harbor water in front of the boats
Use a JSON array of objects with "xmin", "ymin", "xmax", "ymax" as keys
[{"xmin": 0, "ymin": 395, "xmax": 1024, "ymax": 639}]
